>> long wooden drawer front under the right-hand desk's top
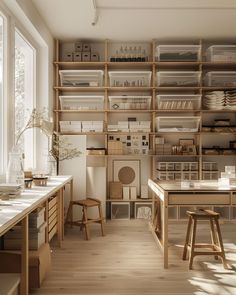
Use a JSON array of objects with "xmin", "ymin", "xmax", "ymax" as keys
[{"xmin": 168, "ymin": 192, "xmax": 230, "ymax": 205}]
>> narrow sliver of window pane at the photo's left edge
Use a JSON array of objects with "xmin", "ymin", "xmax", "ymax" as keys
[{"xmin": 0, "ymin": 12, "xmax": 5, "ymax": 174}]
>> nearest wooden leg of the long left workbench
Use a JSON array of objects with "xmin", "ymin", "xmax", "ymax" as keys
[{"xmin": 20, "ymin": 216, "xmax": 29, "ymax": 295}]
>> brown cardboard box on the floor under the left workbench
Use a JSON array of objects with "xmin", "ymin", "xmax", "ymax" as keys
[{"xmin": 0, "ymin": 243, "xmax": 51, "ymax": 289}]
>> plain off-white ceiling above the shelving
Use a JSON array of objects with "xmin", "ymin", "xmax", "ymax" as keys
[{"xmin": 32, "ymin": 0, "xmax": 236, "ymax": 40}]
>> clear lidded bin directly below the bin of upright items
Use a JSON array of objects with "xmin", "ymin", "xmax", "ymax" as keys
[{"xmin": 156, "ymin": 116, "xmax": 200, "ymax": 132}]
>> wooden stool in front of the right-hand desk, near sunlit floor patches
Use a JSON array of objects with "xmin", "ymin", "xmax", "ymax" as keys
[{"xmin": 183, "ymin": 209, "xmax": 228, "ymax": 269}]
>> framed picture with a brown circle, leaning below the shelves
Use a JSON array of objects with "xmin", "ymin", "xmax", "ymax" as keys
[{"xmin": 113, "ymin": 160, "xmax": 140, "ymax": 196}]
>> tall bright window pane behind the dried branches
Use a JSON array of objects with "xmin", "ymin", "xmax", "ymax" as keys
[{"xmin": 15, "ymin": 30, "xmax": 35, "ymax": 169}]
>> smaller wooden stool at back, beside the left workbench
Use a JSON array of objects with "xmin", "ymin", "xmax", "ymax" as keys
[{"xmin": 67, "ymin": 198, "xmax": 105, "ymax": 240}]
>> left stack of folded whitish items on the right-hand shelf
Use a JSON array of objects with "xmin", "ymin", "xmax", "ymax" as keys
[{"xmin": 203, "ymin": 91, "xmax": 225, "ymax": 110}]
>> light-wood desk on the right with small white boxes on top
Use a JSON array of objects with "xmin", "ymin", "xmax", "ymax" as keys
[{"xmin": 148, "ymin": 179, "xmax": 236, "ymax": 268}]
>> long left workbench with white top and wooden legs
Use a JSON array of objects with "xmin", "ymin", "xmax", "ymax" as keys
[{"xmin": 0, "ymin": 176, "xmax": 73, "ymax": 295}]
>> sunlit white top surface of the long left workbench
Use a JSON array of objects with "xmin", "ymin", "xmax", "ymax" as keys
[{"xmin": 0, "ymin": 175, "xmax": 72, "ymax": 236}]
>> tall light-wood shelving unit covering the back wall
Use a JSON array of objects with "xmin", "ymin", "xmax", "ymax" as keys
[{"xmin": 54, "ymin": 40, "xmax": 236, "ymax": 220}]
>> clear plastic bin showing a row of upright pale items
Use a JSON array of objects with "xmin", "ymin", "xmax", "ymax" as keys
[{"xmin": 156, "ymin": 94, "xmax": 201, "ymax": 110}]
